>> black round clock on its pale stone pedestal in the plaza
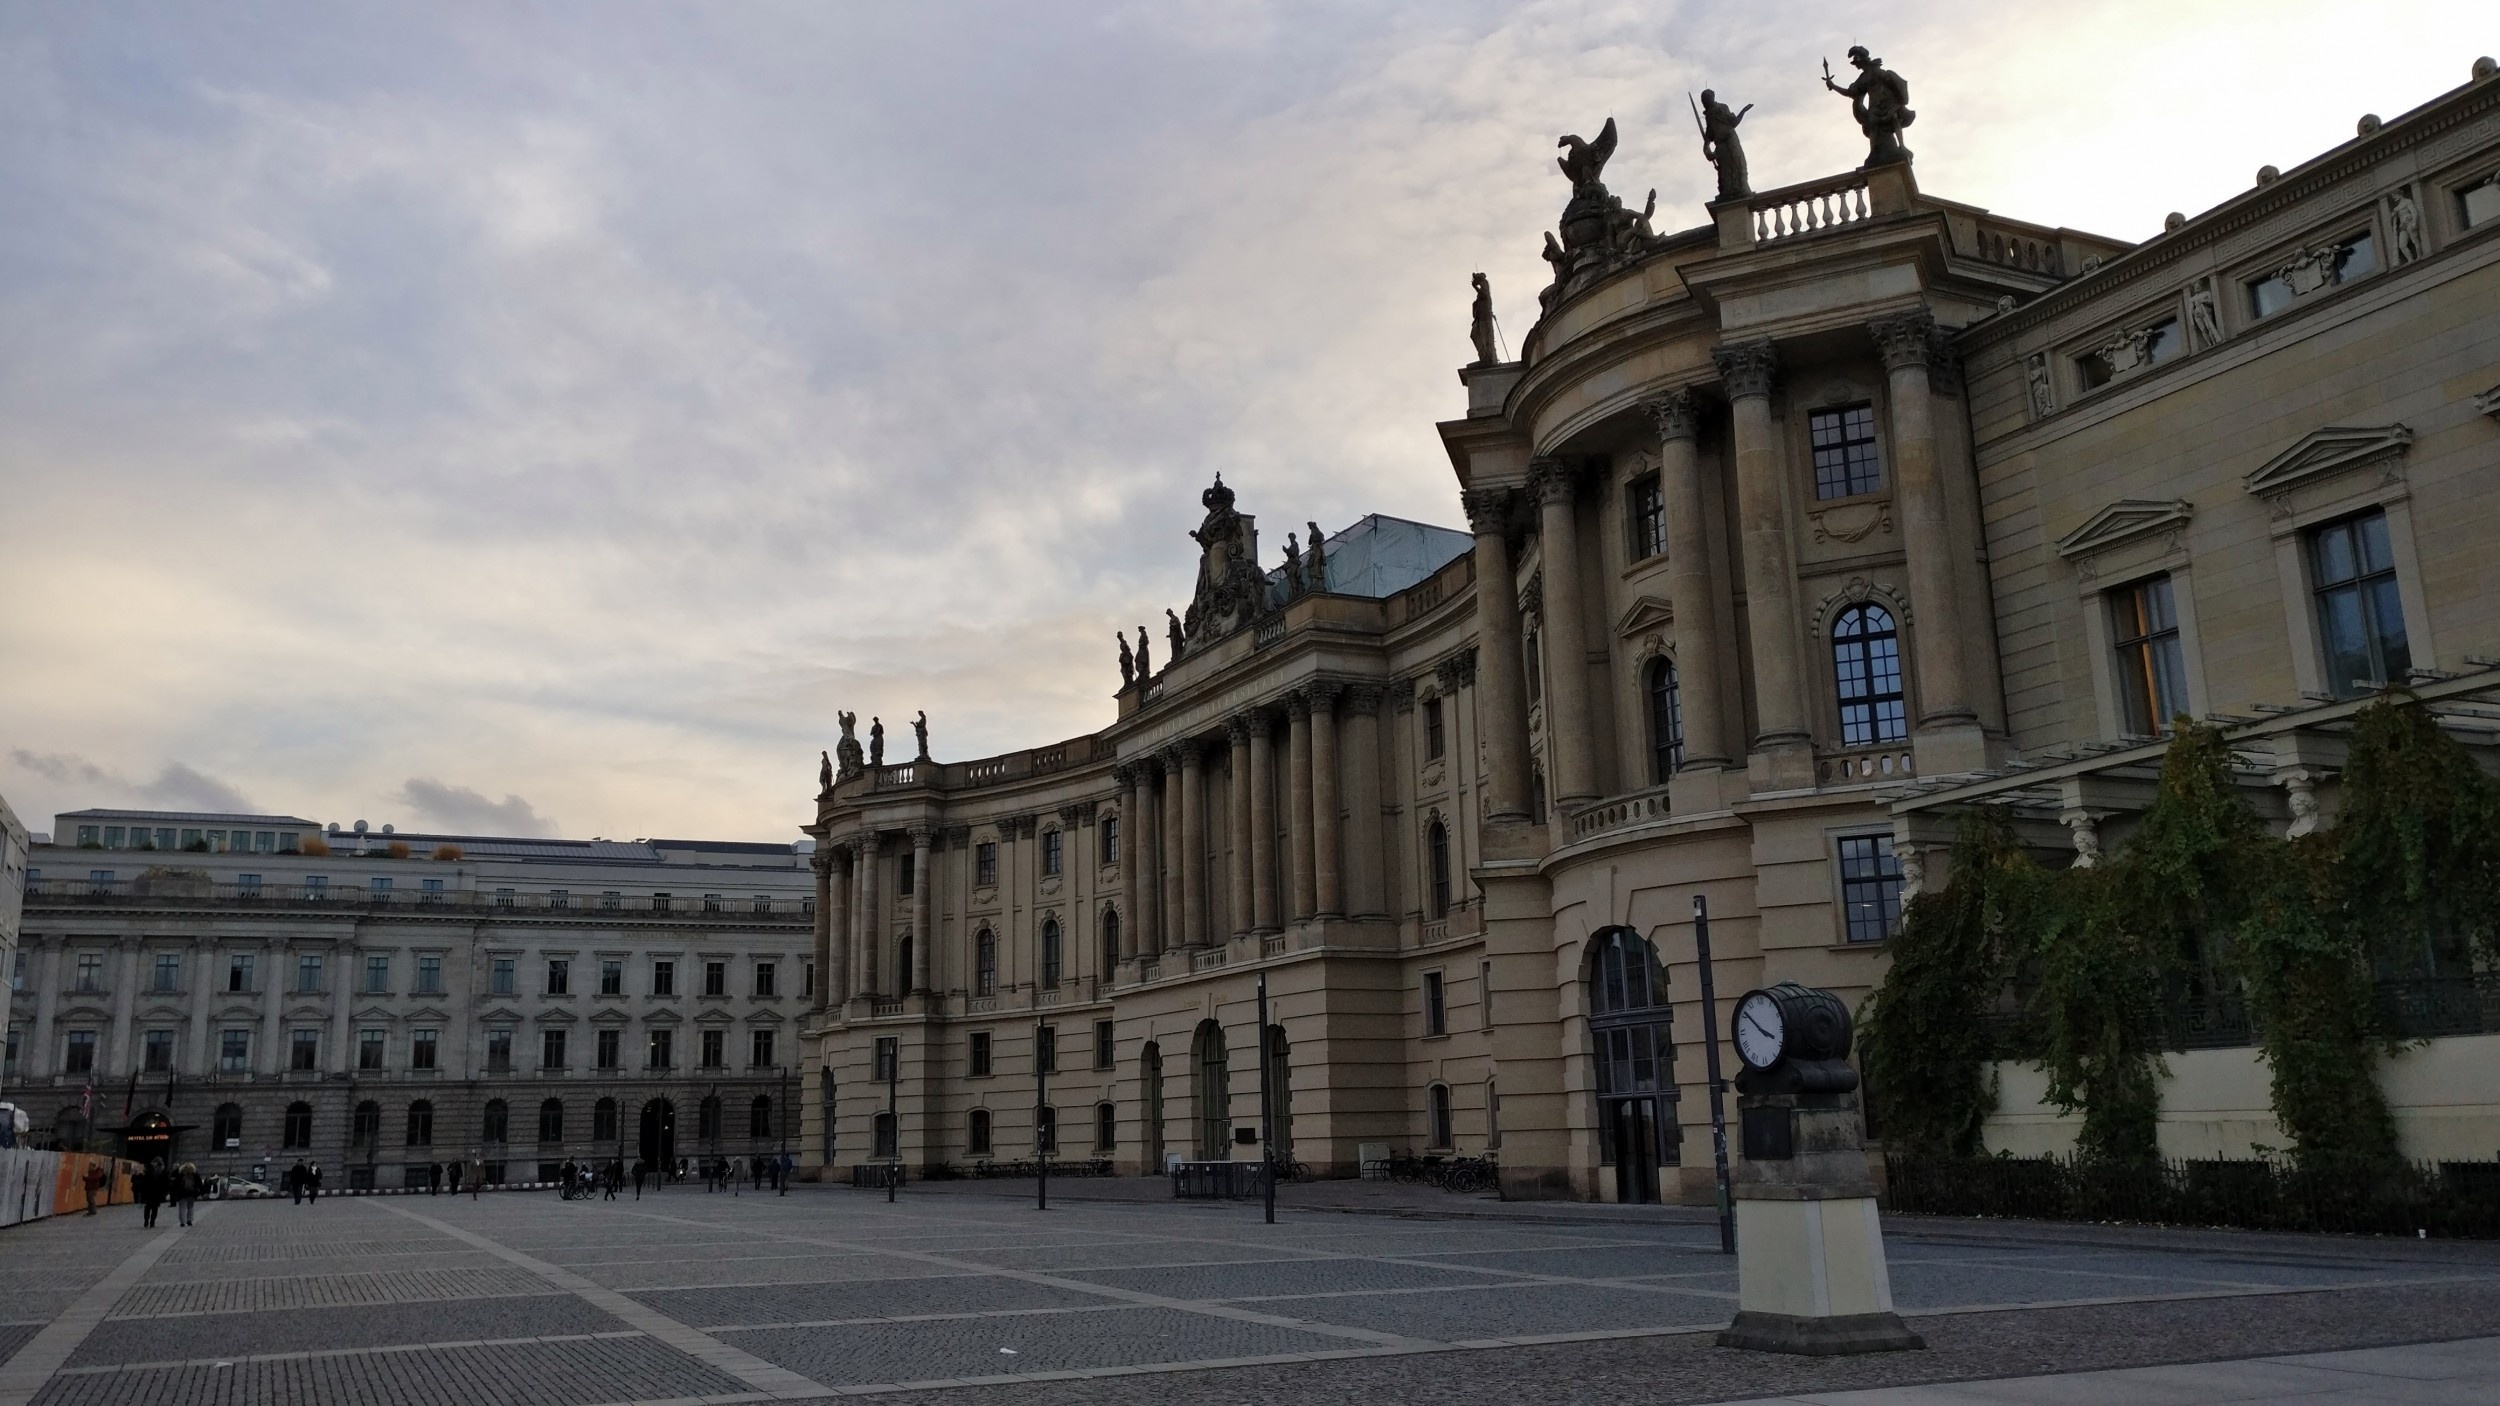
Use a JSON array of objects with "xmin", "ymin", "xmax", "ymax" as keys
[{"xmin": 1718, "ymin": 988, "xmax": 1928, "ymax": 1356}]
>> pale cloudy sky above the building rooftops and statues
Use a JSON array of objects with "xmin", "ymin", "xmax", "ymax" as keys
[{"xmin": 0, "ymin": 0, "xmax": 2500, "ymax": 838}]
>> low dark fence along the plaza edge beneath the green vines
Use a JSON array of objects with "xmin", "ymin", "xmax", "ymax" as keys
[{"xmin": 1883, "ymin": 1153, "xmax": 2500, "ymax": 1241}]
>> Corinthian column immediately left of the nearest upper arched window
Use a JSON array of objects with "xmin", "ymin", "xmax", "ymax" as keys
[{"xmin": 1710, "ymin": 340, "xmax": 1813, "ymax": 770}]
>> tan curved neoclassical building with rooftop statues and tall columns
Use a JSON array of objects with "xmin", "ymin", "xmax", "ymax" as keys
[{"xmin": 805, "ymin": 63, "xmax": 2500, "ymax": 1201}]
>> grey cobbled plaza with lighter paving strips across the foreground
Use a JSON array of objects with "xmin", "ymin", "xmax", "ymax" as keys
[{"xmin": 0, "ymin": 1183, "xmax": 2500, "ymax": 1406}]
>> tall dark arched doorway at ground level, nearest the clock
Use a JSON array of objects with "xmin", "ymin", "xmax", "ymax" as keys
[{"xmin": 1588, "ymin": 928, "xmax": 1683, "ymax": 1203}]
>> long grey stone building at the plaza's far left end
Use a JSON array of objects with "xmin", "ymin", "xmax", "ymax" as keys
[{"xmin": 0, "ymin": 811, "xmax": 815, "ymax": 1186}]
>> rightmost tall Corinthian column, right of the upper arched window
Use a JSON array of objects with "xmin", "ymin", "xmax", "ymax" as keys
[{"xmin": 1868, "ymin": 313, "xmax": 1978, "ymax": 725}]
